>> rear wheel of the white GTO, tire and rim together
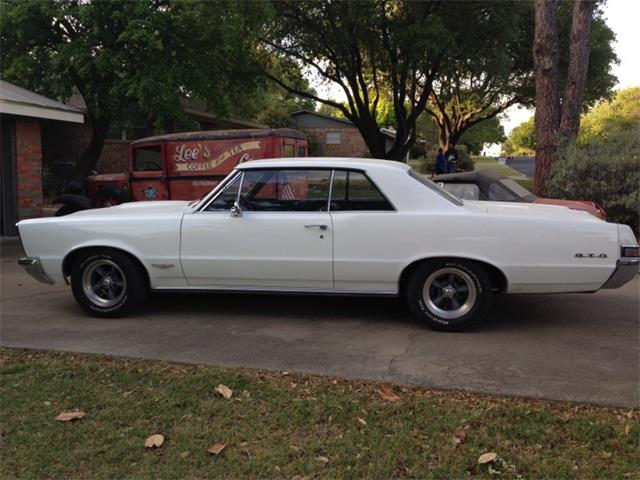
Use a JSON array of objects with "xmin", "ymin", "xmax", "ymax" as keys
[{"xmin": 406, "ymin": 259, "xmax": 492, "ymax": 332}]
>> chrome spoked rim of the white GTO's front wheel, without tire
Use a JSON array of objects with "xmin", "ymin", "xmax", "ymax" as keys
[{"xmin": 82, "ymin": 258, "xmax": 127, "ymax": 308}]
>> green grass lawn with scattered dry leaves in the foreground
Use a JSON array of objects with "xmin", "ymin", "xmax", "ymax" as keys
[{"xmin": 0, "ymin": 349, "xmax": 640, "ymax": 479}]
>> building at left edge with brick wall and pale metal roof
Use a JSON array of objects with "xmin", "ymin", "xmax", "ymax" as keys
[{"xmin": 0, "ymin": 80, "xmax": 84, "ymax": 235}]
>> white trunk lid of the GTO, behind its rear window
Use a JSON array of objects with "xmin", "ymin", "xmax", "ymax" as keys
[{"xmin": 464, "ymin": 200, "xmax": 601, "ymax": 222}]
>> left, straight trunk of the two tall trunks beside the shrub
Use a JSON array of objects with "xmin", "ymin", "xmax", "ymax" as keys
[{"xmin": 533, "ymin": 0, "xmax": 560, "ymax": 195}]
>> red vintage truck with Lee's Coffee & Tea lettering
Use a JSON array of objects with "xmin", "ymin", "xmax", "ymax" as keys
[{"xmin": 54, "ymin": 128, "xmax": 309, "ymax": 215}]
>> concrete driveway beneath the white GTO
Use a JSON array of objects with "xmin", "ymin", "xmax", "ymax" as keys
[{"xmin": 0, "ymin": 236, "xmax": 640, "ymax": 407}]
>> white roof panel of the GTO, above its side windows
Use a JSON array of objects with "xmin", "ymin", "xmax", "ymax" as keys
[{"xmin": 237, "ymin": 157, "xmax": 411, "ymax": 171}]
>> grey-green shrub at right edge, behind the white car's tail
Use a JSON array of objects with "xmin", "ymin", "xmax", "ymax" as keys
[{"xmin": 545, "ymin": 130, "xmax": 640, "ymax": 235}]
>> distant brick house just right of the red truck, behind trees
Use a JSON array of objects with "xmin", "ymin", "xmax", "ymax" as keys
[{"xmin": 291, "ymin": 110, "xmax": 404, "ymax": 157}]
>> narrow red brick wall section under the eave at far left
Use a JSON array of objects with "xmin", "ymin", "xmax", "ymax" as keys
[{"xmin": 16, "ymin": 117, "xmax": 43, "ymax": 220}]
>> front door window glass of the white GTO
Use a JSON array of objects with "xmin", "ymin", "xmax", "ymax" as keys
[{"xmin": 240, "ymin": 170, "xmax": 331, "ymax": 212}]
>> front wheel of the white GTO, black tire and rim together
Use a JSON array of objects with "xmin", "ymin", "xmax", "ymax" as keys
[{"xmin": 71, "ymin": 249, "xmax": 149, "ymax": 318}]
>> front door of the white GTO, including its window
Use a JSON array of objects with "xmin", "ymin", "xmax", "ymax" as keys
[{"xmin": 181, "ymin": 169, "xmax": 333, "ymax": 290}]
